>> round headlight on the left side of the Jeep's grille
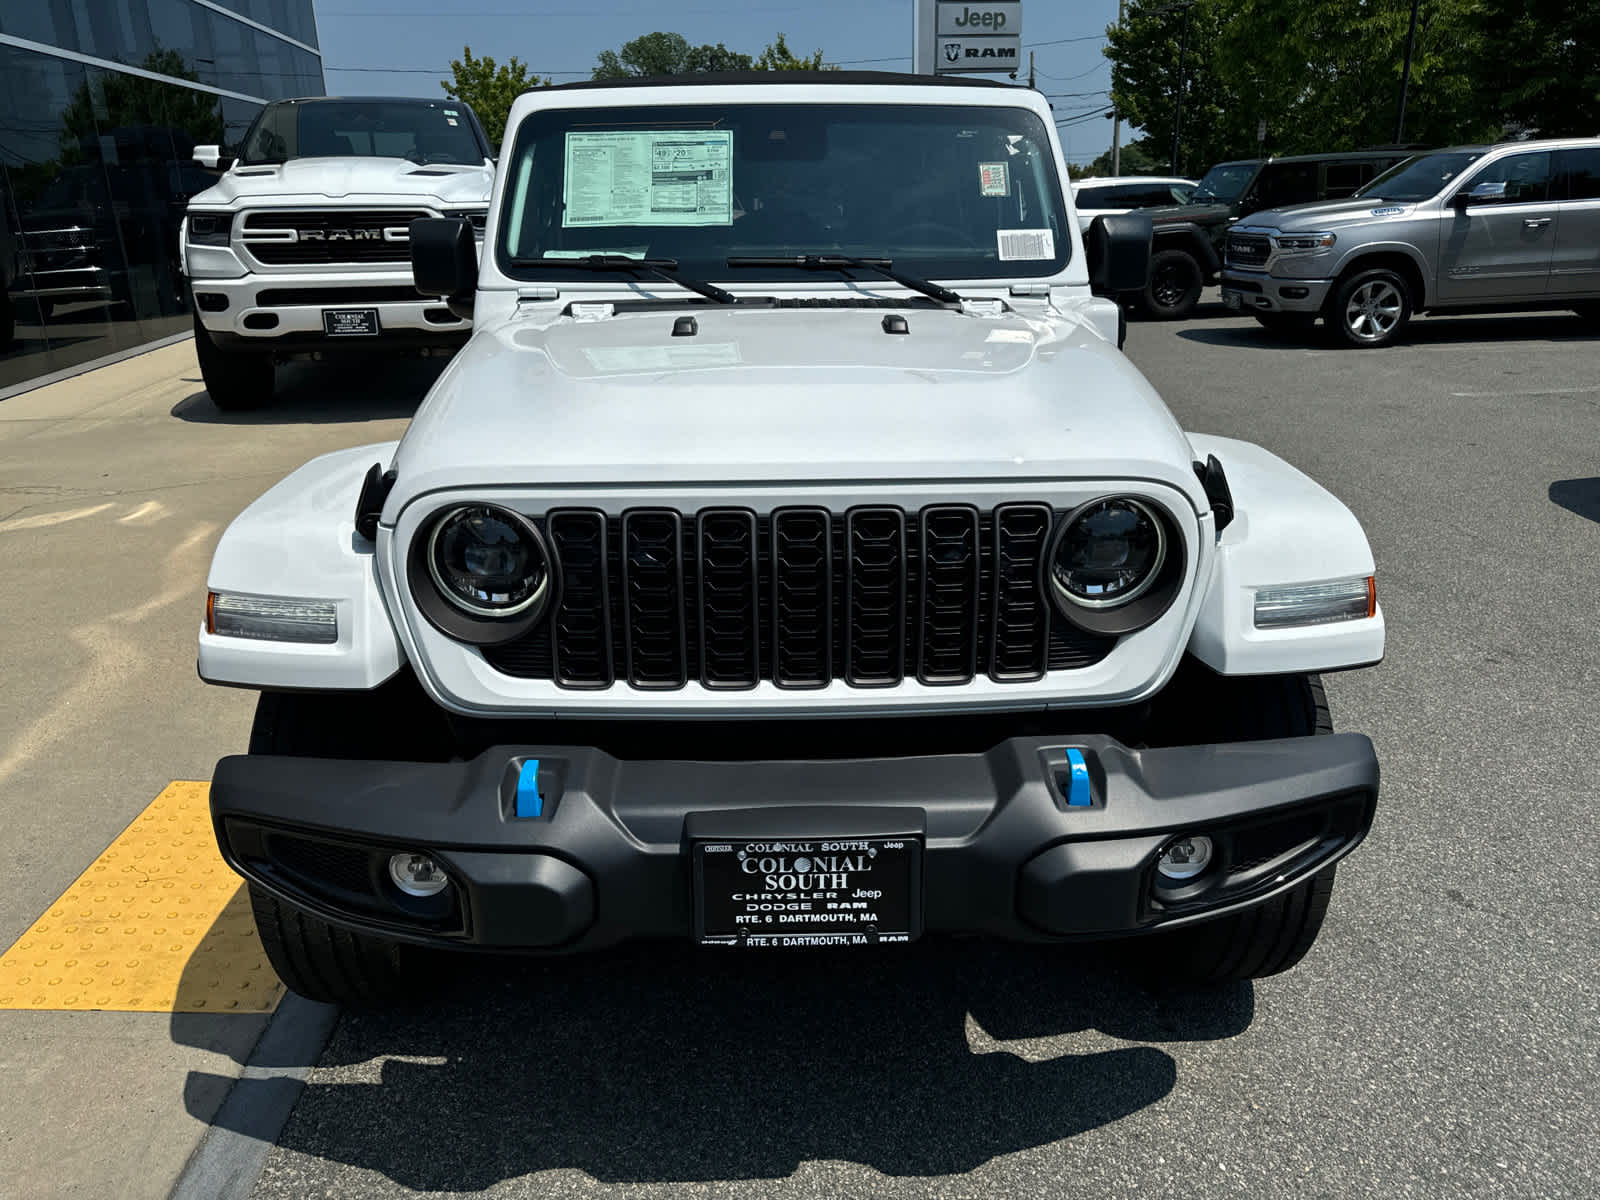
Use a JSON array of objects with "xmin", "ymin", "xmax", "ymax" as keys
[{"xmin": 427, "ymin": 504, "xmax": 550, "ymax": 619}]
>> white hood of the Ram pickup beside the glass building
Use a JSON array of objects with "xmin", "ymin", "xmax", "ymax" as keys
[{"xmin": 190, "ymin": 157, "xmax": 494, "ymax": 208}]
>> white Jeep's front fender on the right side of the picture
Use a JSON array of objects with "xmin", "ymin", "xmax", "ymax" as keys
[{"xmin": 1189, "ymin": 434, "xmax": 1384, "ymax": 675}]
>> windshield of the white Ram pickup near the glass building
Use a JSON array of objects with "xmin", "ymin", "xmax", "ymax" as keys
[{"xmin": 238, "ymin": 101, "xmax": 490, "ymax": 165}]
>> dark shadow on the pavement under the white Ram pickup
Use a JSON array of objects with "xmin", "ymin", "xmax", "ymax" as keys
[{"xmin": 171, "ymin": 358, "xmax": 448, "ymax": 426}]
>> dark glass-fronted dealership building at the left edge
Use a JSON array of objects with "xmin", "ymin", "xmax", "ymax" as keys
[{"xmin": 0, "ymin": 0, "xmax": 325, "ymax": 395}]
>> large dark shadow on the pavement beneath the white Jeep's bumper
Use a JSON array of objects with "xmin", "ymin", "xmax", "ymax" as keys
[{"xmin": 174, "ymin": 939, "xmax": 1254, "ymax": 1192}]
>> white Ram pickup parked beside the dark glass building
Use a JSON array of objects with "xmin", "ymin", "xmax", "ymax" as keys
[{"xmin": 179, "ymin": 98, "xmax": 494, "ymax": 410}]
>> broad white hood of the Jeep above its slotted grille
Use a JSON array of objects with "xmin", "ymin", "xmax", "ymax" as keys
[{"xmin": 387, "ymin": 306, "xmax": 1206, "ymax": 514}]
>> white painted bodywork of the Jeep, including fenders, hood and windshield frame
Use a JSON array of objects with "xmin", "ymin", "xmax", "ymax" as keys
[{"xmin": 192, "ymin": 85, "xmax": 1382, "ymax": 704}]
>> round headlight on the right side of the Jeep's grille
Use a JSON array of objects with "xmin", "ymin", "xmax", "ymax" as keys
[{"xmin": 1045, "ymin": 496, "xmax": 1182, "ymax": 634}]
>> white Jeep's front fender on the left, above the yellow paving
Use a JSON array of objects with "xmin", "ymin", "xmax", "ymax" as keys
[{"xmin": 198, "ymin": 442, "xmax": 405, "ymax": 690}]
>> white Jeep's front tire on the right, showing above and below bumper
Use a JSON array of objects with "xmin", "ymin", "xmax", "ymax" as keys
[{"xmin": 1126, "ymin": 669, "xmax": 1334, "ymax": 987}]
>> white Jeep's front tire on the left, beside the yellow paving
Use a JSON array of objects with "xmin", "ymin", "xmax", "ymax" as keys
[{"xmin": 250, "ymin": 675, "xmax": 450, "ymax": 1008}]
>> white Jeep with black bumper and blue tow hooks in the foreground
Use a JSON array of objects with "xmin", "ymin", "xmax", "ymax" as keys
[{"xmin": 198, "ymin": 72, "xmax": 1384, "ymax": 1005}]
